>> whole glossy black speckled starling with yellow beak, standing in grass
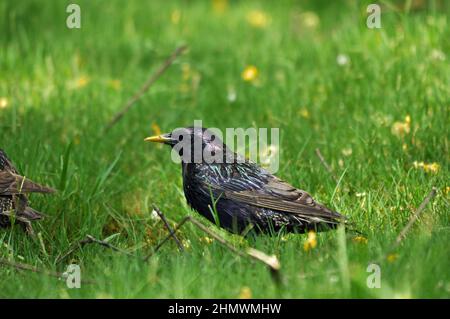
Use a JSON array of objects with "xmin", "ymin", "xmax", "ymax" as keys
[{"xmin": 145, "ymin": 127, "xmax": 345, "ymax": 234}]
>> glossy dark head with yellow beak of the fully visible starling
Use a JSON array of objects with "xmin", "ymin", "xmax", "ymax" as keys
[{"xmin": 145, "ymin": 127, "xmax": 235, "ymax": 163}]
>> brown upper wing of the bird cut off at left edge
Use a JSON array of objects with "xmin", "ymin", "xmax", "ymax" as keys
[{"xmin": 0, "ymin": 170, "xmax": 55, "ymax": 195}]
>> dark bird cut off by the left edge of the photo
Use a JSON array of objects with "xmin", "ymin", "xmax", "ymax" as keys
[{"xmin": 0, "ymin": 149, "xmax": 54, "ymax": 234}]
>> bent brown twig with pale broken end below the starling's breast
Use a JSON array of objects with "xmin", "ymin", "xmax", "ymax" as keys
[{"xmin": 144, "ymin": 216, "xmax": 281, "ymax": 281}]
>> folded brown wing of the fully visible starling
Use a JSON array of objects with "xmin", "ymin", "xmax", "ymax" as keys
[{"xmin": 209, "ymin": 175, "xmax": 344, "ymax": 223}]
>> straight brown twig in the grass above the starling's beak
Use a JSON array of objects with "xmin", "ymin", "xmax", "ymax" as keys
[{"xmin": 104, "ymin": 45, "xmax": 187, "ymax": 132}]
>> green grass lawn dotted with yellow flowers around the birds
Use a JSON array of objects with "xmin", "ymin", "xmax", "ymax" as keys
[{"xmin": 0, "ymin": 0, "xmax": 450, "ymax": 298}]
